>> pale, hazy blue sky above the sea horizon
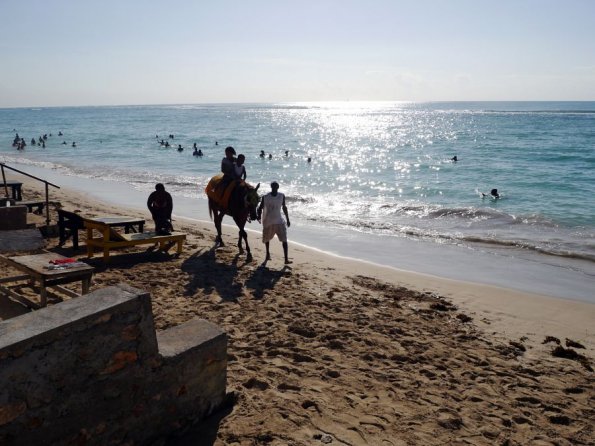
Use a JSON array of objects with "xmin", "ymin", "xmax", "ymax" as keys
[{"xmin": 0, "ymin": 0, "xmax": 595, "ymax": 107}]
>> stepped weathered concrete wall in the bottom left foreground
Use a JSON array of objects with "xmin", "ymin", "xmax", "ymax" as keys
[{"xmin": 0, "ymin": 284, "xmax": 227, "ymax": 445}]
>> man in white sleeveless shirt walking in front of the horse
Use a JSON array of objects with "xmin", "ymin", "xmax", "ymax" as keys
[{"xmin": 257, "ymin": 181, "xmax": 291, "ymax": 265}]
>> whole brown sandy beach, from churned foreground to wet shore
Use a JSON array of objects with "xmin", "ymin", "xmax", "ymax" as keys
[{"xmin": 0, "ymin": 175, "xmax": 595, "ymax": 445}]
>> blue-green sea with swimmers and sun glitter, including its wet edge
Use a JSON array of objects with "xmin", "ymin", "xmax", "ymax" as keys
[{"xmin": 0, "ymin": 102, "xmax": 595, "ymax": 299}]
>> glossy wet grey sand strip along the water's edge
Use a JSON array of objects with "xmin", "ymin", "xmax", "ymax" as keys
[{"xmin": 5, "ymin": 163, "xmax": 595, "ymax": 304}]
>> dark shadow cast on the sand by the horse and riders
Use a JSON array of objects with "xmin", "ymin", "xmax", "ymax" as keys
[{"xmin": 181, "ymin": 247, "xmax": 243, "ymax": 302}]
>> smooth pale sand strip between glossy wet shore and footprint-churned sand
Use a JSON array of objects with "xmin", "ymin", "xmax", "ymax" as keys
[{"xmin": 9, "ymin": 171, "xmax": 595, "ymax": 347}]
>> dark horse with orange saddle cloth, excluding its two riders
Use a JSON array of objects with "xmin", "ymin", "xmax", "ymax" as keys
[{"xmin": 209, "ymin": 182, "xmax": 260, "ymax": 262}]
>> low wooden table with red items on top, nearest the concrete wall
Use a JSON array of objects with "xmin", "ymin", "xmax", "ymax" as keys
[{"xmin": 0, "ymin": 252, "xmax": 95, "ymax": 308}]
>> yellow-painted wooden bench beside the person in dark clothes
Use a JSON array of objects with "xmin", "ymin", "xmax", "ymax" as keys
[{"xmin": 84, "ymin": 219, "xmax": 186, "ymax": 262}]
